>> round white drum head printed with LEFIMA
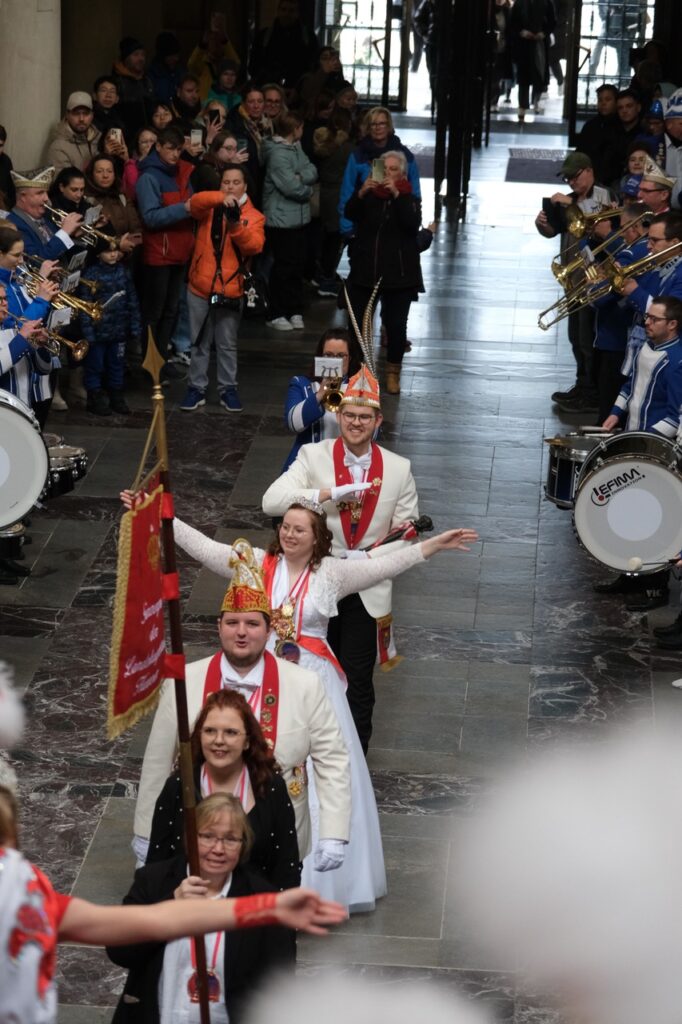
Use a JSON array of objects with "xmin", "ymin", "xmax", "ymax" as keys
[{"xmin": 573, "ymin": 456, "xmax": 682, "ymax": 572}]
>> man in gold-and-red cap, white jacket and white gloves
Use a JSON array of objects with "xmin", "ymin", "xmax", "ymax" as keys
[{"xmin": 133, "ymin": 541, "xmax": 350, "ymax": 884}]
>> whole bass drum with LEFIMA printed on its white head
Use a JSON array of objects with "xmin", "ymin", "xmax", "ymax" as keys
[{"xmin": 573, "ymin": 431, "xmax": 682, "ymax": 573}]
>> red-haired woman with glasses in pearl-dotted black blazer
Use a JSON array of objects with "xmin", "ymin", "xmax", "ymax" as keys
[{"xmin": 146, "ymin": 689, "xmax": 301, "ymax": 890}]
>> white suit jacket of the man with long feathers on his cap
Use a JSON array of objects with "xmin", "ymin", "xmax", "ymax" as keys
[{"xmin": 263, "ymin": 439, "xmax": 419, "ymax": 618}]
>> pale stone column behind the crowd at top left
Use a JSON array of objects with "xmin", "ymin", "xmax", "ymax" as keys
[{"xmin": 0, "ymin": 0, "xmax": 61, "ymax": 170}]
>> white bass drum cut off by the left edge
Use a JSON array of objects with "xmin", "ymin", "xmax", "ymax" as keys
[{"xmin": 0, "ymin": 391, "xmax": 48, "ymax": 529}]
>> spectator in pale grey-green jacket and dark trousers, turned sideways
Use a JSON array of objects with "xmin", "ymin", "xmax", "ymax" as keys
[{"xmin": 263, "ymin": 113, "xmax": 317, "ymax": 331}]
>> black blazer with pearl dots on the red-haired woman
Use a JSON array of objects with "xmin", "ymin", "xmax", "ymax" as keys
[{"xmin": 146, "ymin": 765, "xmax": 301, "ymax": 891}]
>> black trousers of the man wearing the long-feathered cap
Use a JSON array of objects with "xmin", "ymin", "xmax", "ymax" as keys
[{"xmin": 327, "ymin": 594, "xmax": 377, "ymax": 754}]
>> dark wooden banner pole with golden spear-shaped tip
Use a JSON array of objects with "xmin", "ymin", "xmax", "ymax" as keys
[{"xmin": 142, "ymin": 328, "xmax": 211, "ymax": 1024}]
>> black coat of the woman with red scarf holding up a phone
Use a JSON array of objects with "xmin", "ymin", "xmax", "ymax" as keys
[{"xmin": 345, "ymin": 189, "xmax": 424, "ymax": 292}]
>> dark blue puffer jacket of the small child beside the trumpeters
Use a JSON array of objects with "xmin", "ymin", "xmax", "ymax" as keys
[{"xmin": 78, "ymin": 260, "xmax": 142, "ymax": 345}]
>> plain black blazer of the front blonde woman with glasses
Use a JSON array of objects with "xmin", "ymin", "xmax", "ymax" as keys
[{"xmin": 106, "ymin": 857, "xmax": 296, "ymax": 1024}]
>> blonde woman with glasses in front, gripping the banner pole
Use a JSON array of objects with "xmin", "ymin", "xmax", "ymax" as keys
[{"xmin": 106, "ymin": 793, "xmax": 296, "ymax": 1024}]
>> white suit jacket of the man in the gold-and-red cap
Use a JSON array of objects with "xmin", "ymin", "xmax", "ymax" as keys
[{"xmin": 134, "ymin": 657, "xmax": 350, "ymax": 859}]
